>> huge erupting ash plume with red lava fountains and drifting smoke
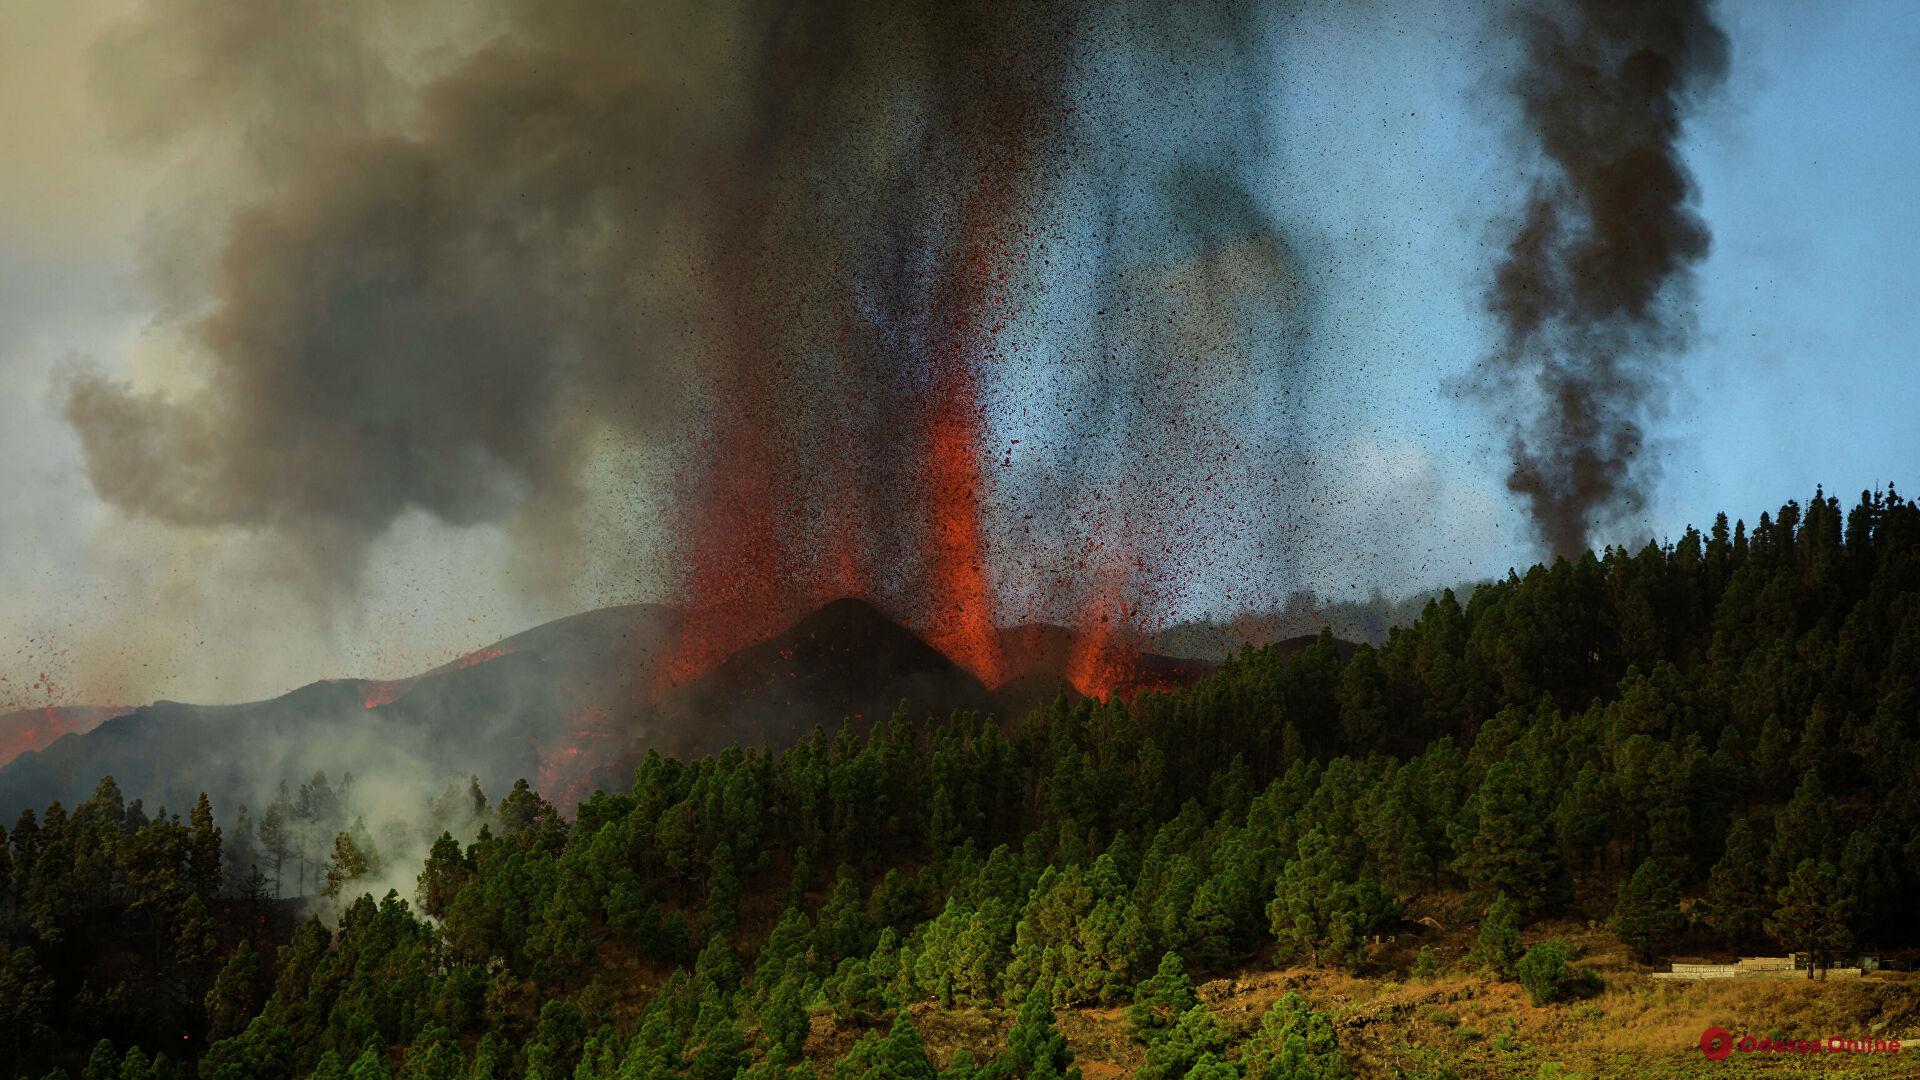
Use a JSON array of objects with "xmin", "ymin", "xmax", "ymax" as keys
[{"xmin": 67, "ymin": 0, "xmax": 1300, "ymax": 682}]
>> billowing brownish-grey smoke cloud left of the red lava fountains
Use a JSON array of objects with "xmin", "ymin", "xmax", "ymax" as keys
[{"xmin": 65, "ymin": 0, "xmax": 714, "ymax": 580}]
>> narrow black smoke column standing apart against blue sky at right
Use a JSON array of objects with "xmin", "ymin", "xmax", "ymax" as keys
[{"xmin": 1482, "ymin": 0, "xmax": 1726, "ymax": 557}]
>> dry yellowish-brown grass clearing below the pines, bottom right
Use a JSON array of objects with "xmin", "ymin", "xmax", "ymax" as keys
[{"xmin": 808, "ymin": 914, "xmax": 1920, "ymax": 1080}]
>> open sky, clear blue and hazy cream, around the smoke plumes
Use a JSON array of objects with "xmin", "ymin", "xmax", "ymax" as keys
[{"xmin": 0, "ymin": 0, "xmax": 1920, "ymax": 705}]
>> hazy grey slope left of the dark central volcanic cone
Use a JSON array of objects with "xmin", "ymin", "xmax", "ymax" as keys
[{"xmin": 0, "ymin": 603, "xmax": 678, "ymax": 821}]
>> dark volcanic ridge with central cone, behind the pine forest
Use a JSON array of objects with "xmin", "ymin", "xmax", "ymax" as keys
[{"xmin": 0, "ymin": 598, "xmax": 1213, "ymax": 817}]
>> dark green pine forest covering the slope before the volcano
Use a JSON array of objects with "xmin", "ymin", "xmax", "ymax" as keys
[{"xmin": 0, "ymin": 492, "xmax": 1920, "ymax": 1080}]
